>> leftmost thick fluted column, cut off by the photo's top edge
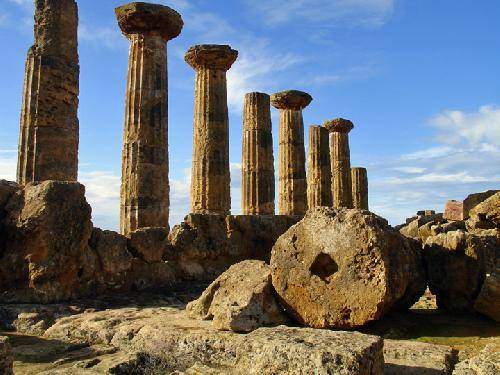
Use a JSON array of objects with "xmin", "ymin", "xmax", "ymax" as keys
[{"xmin": 17, "ymin": 0, "xmax": 80, "ymax": 185}]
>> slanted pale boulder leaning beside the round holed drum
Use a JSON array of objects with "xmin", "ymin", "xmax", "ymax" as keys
[{"xmin": 186, "ymin": 260, "xmax": 287, "ymax": 332}]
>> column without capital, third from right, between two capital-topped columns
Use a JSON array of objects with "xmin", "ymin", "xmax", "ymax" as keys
[{"xmin": 307, "ymin": 125, "xmax": 332, "ymax": 209}]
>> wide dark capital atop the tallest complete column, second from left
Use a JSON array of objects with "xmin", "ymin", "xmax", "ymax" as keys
[{"xmin": 115, "ymin": 2, "xmax": 184, "ymax": 41}]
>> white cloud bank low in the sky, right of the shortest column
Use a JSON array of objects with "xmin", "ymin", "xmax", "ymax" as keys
[{"xmin": 369, "ymin": 106, "xmax": 500, "ymax": 224}]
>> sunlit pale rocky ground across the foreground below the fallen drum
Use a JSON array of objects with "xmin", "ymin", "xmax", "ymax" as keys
[{"xmin": 0, "ymin": 289, "xmax": 500, "ymax": 375}]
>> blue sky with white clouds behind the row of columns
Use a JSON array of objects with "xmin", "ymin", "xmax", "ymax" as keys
[{"xmin": 0, "ymin": 0, "xmax": 500, "ymax": 229}]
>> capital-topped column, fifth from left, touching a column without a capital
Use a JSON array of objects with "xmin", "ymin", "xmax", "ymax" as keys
[{"xmin": 271, "ymin": 90, "xmax": 312, "ymax": 215}]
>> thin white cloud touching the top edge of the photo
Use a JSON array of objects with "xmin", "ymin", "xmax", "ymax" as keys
[{"xmin": 248, "ymin": 0, "xmax": 396, "ymax": 28}]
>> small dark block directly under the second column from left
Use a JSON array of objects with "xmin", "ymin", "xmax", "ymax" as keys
[{"xmin": 128, "ymin": 228, "xmax": 169, "ymax": 263}]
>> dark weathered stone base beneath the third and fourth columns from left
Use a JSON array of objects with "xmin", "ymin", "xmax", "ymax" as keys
[{"xmin": 169, "ymin": 214, "xmax": 300, "ymax": 282}]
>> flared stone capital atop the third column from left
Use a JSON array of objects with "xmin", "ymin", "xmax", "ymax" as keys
[{"xmin": 184, "ymin": 44, "xmax": 238, "ymax": 71}]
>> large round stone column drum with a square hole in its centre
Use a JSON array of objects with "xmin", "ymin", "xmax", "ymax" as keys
[{"xmin": 271, "ymin": 207, "xmax": 426, "ymax": 329}]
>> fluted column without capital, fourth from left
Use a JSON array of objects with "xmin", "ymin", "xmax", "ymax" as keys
[{"xmin": 241, "ymin": 92, "xmax": 275, "ymax": 215}]
